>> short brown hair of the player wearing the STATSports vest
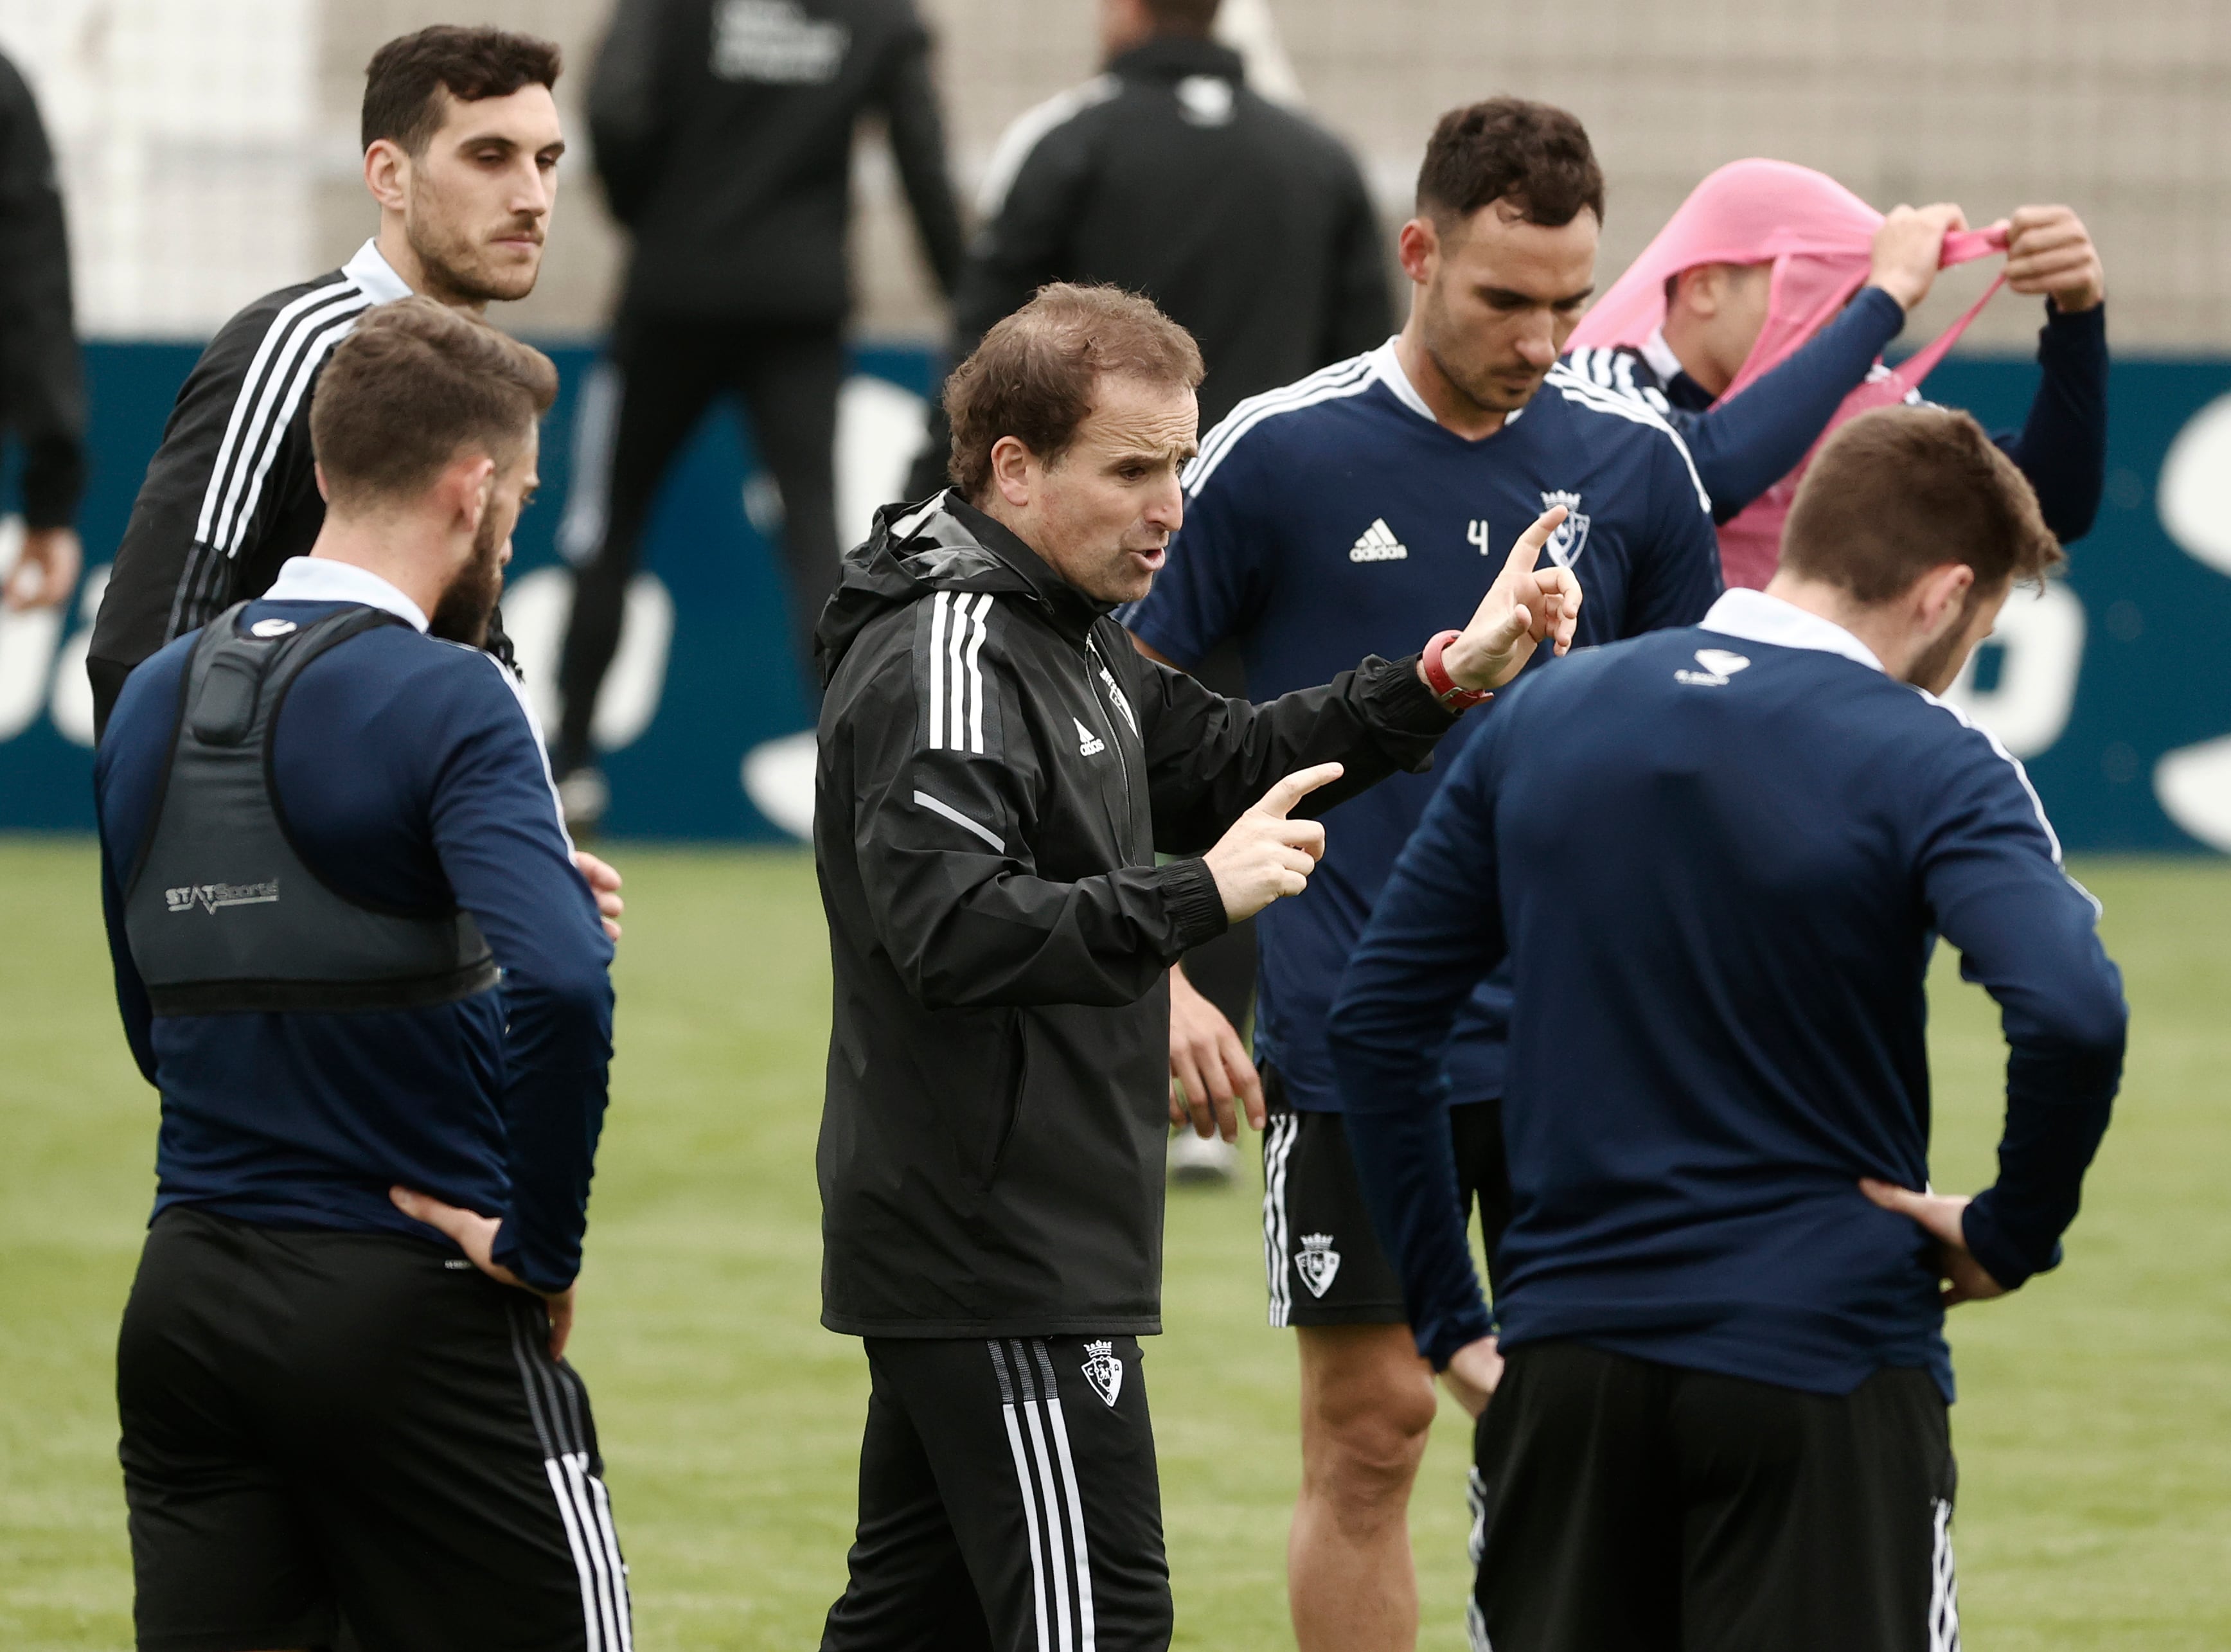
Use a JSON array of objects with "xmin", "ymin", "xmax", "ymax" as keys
[{"xmin": 310, "ymin": 295, "xmax": 558, "ymax": 509}]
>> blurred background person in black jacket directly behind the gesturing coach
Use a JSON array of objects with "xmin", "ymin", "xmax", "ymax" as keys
[{"xmin": 908, "ymin": 0, "xmax": 1394, "ymax": 1044}]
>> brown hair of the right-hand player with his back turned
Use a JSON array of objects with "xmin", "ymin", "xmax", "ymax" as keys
[{"xmin": 1782, "ymin": 406, "xmax": 2068, "ymax": 603}]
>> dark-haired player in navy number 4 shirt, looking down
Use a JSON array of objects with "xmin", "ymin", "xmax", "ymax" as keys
[{"xmin": 1126, "ymin": 98, "xmax": 1720, "ymax": 1652}]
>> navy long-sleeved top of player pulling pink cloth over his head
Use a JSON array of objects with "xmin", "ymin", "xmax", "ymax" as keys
[{"xmin": 1569, "ymin": 286, "xmax": 2106, "ymax": 545}]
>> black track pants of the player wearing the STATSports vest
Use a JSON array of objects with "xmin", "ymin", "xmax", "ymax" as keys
[{"xmin": 116, "ymin": 1208, "xmax": 632, "ymax": 1652}]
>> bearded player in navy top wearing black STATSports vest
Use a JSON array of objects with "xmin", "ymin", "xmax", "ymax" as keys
[{"xmin": 94, "ymin": 297, "xmax": 629, "ymax": 1652}]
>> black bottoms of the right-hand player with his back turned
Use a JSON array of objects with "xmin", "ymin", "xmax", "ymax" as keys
[{"xmin": 1473, "ymin": 1342, "xmax": 1959, "ymax": 1652}]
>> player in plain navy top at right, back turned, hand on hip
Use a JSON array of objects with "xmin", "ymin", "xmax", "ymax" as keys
[{"xmin": 1332, "ymin": 406, "xmax": 2126, "ymax": 1652}]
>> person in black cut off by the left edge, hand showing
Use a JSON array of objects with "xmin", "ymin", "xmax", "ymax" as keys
[{"xmin": 0, "ymin": 56, "xmax": 85, "ymax": 605}]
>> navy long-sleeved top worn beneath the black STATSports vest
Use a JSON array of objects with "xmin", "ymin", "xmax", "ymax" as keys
[{"xmin": 94, "ymin": 563, "xmax": 611, "ymax": 1290}]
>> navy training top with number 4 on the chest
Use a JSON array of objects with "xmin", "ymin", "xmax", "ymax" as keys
[{"xmin": 1120, "ymin": 339, "xmax": 1720, "ymax": 1112}]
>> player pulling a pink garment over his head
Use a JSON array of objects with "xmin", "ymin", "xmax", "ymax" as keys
[{"xmin": 1570, "ymin": 161, "xmax": 2106, "ymax": 587}]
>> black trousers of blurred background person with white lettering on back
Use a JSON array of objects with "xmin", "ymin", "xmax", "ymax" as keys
[{"xmin": 556, "ymin": 315, "xmax": 843, "ymax": 772}]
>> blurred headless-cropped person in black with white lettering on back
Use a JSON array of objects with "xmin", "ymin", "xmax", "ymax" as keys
[{"xmin": 556, "ymin": 0, "xmax": 961, "ymax": 794}]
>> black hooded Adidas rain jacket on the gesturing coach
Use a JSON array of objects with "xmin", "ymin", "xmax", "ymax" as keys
[{"xmin": 814, "ymin": 493, "xmax": 1455, "ymax": 1337}]
